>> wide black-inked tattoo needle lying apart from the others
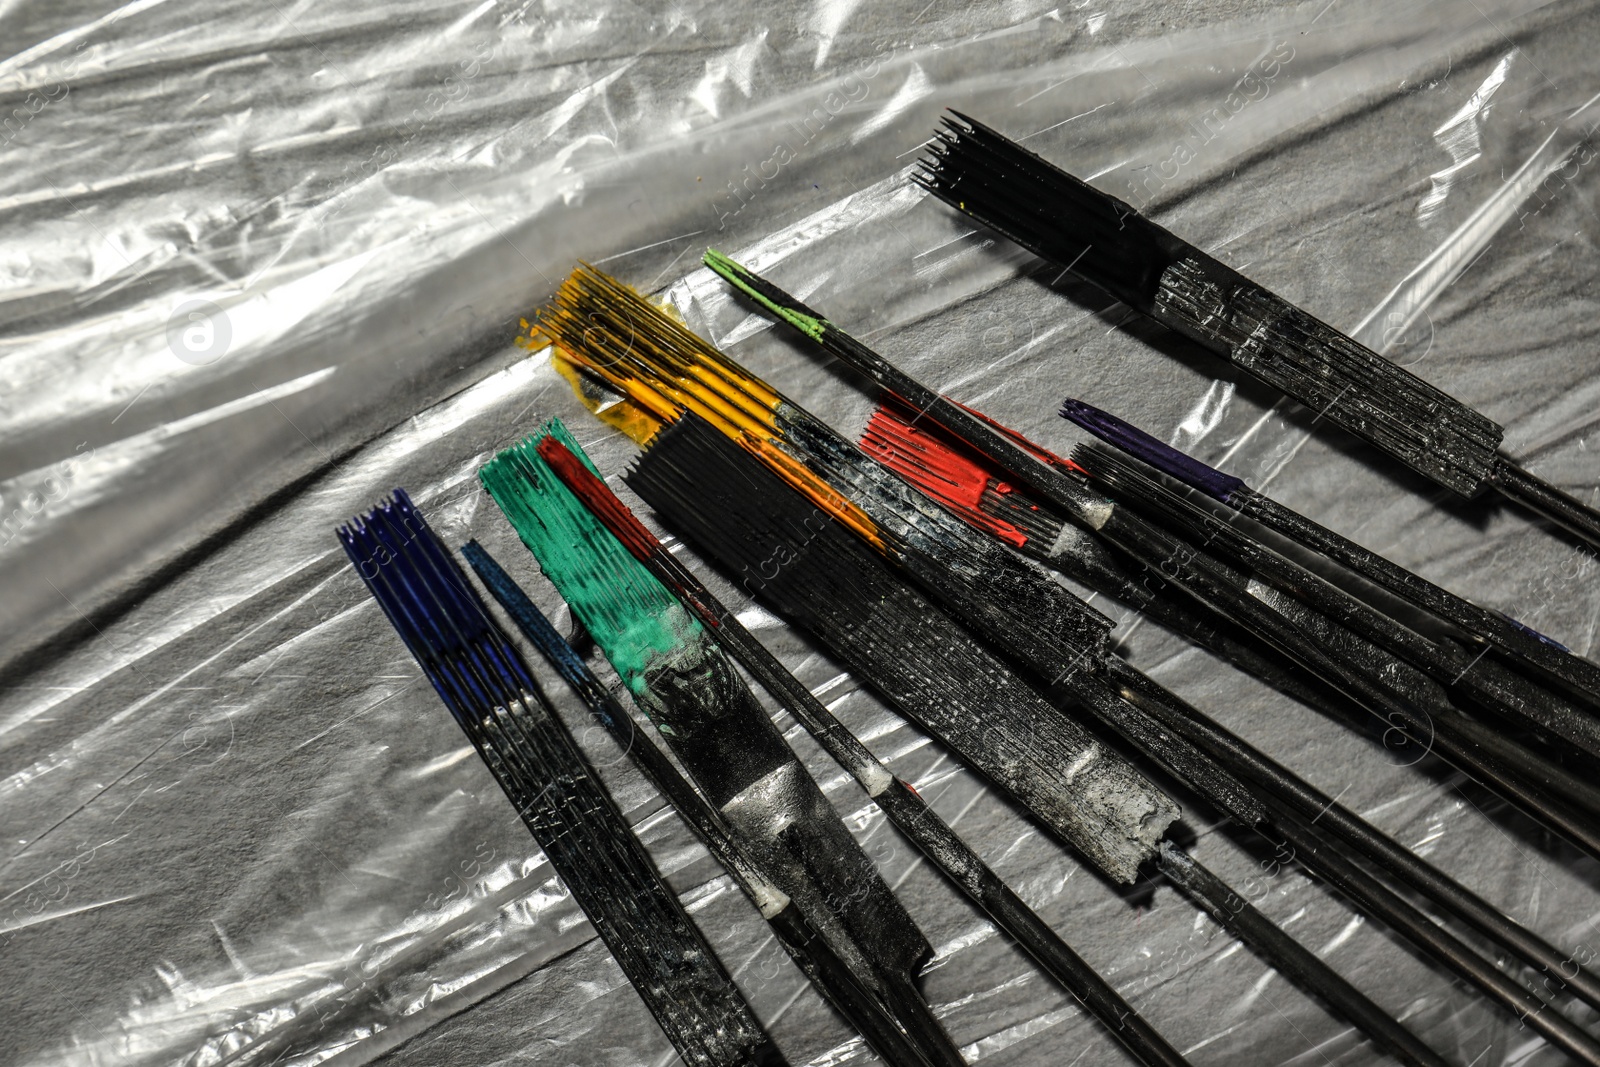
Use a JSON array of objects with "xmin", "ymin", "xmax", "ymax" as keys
[{"xmin": 917, "ymin": 112, "xmax": 1600, "ymax": 547}]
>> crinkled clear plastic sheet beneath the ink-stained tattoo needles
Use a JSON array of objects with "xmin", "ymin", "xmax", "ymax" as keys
[{"xmin": 9, "ymin": 0, "xmax": 1600, "ymax": 1067}]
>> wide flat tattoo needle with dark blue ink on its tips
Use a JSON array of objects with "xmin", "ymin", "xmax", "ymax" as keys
[{"xmin": 339, "ymin": 490, "xmax": 784, "ymax": 1067}]
